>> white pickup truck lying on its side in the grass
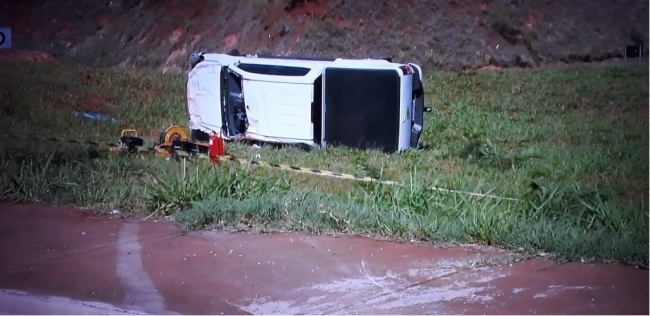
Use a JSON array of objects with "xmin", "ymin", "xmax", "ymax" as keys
[{"xmin": 187, "ymin": 53, "xmax": 425, "ymax": 152}]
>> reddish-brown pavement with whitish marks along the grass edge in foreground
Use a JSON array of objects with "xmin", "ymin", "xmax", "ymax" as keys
[{"xmin": 0, "ymin": 204, "xmax": 649, "ymax": 315}]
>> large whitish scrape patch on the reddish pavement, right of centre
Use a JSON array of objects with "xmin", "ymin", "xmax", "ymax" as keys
[{"xmin": 239, "ymin": 262, "xmax": 505, "ymax": 314}]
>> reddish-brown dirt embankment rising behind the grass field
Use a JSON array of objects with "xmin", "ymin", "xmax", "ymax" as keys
[{"xmin": 0, "ymin": 0, "xmax": 648, "ymax": 70}]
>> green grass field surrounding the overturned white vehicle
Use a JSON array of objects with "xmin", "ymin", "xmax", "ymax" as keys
[{"xmin": 0, "ymin": 59, "xmax": 649, "ymax": 266}]
